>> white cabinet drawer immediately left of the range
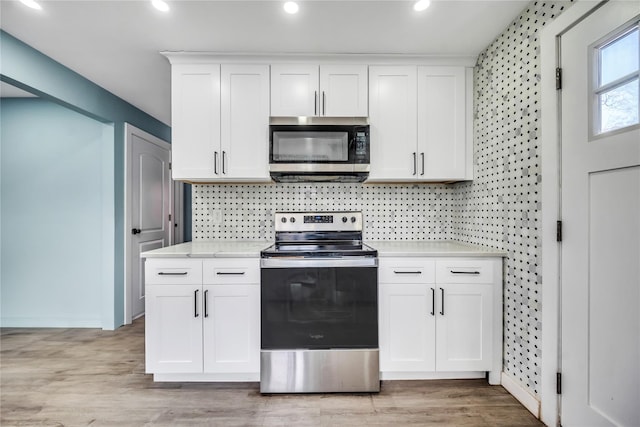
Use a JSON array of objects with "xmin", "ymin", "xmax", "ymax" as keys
[{"xmin": 202, "ymin": 258, "xmax": 260, "ymax": 285}]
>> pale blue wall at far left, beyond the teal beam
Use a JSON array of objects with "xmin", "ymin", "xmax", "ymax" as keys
[{"xmin": 0, "ymin": 98, "xmax": 114, "ymax": 327}]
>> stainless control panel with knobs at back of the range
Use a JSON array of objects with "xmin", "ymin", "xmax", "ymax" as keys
[{"xmin": 275, "ymin": 211, "xmax": 362, "ymax": 232}]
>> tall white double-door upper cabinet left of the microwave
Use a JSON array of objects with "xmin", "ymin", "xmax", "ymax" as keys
[{"xmin": 171, "ymin": 64, "xmax": 270, "ymax": 182}]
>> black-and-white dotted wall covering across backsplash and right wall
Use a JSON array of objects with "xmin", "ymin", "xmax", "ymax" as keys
[{"xmin": 192, "ymin": 1, "xmax": 572, "ymax": 402}]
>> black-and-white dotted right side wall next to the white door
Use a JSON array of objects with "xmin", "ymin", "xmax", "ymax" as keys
[{"xmin": 451, "ymin": 1, "xmax": 572, "ymax": 395}]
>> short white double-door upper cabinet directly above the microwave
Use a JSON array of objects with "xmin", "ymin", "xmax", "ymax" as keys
[{"xmin": 271, "ymin": 64, "xmax": 368, "ymax": 117}]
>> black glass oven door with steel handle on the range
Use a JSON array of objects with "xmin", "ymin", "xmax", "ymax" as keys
[{"xmin": 261, "ymin": 258, "xmax": 378, "ymax": 350}]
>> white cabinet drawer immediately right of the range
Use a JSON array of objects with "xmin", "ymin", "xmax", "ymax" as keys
[{"xmin": 378, "ymin": 257, "xmax": 435, "ymax": 283}]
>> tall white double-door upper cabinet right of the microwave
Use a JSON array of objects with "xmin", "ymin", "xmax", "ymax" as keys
[{"xmin": 369, "ymin": 66, "xmax": 472, "ymax": 182}]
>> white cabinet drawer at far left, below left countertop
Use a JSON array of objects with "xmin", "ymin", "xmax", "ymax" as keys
[{"xmin": 144, "ymin": 258, "xmax": 202, "ymax": 285}]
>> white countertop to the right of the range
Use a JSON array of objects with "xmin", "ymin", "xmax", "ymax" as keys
[{"xmin": 365, "ymin": 240, "xmax": 507, "ymax": 257}]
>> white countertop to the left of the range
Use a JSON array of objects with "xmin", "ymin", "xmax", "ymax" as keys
[{"xmin": 140, "ymin": 240, "xmax": 273, "ymax": 258}]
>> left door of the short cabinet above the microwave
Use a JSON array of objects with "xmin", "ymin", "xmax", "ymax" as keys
[{"xmin": 271, "ymin": 64, "xmax": 320, "ymax": 116}]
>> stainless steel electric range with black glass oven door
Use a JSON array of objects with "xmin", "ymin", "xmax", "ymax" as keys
[{"xmin": 260, "ymin": 212, "xmax": 380, "ymax": 393}]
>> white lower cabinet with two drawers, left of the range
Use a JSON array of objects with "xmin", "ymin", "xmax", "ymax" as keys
[{"xmin": 145, "ymin": 258, "xmax": 260, "ymax": 381}]
